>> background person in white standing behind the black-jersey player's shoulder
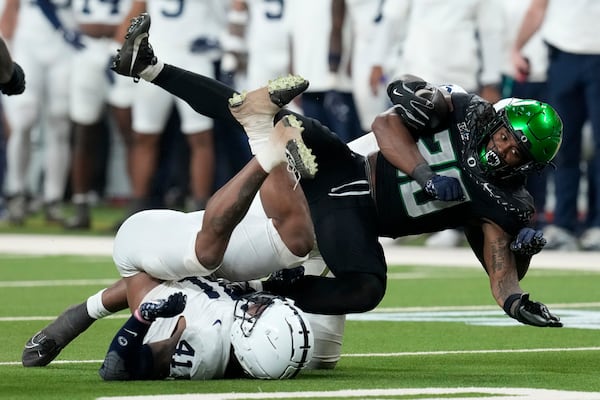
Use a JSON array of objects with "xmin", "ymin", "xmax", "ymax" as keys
[{"xmin": 384, "ymin": 0, "xmax": 504, "ymax": 247}]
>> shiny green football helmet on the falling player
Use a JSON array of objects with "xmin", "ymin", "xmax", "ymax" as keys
[{"xmin": 479, "ymin": 100, "xmax": 563, "ymax": 178}]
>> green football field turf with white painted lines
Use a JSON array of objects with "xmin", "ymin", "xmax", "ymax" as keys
[{"xmin": 0, "ymin": 248, "xmax": 600, "ymax": 399}]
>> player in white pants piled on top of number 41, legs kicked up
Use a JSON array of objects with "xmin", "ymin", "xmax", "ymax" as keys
[{"xmin": 23, "ymin": 89, "xmax": 344, "ymax": 368}]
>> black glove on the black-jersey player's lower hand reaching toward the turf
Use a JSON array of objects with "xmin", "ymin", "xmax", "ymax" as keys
[{"xmin": 503, "ymin": 293, "xmax": 563, "ymax": 328}]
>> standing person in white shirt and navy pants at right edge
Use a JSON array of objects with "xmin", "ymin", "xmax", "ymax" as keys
[{"xmin": 512, "ymin": 0, "xmax": 600, "ymax": 250}]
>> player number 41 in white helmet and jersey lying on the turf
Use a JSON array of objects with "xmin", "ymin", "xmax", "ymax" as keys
[{"xmin": 99, "ymin": 273, "xmax": 313, "ymax": 380}]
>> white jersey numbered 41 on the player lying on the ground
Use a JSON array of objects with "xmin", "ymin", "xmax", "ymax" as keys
[{"xmin": 144, "ymin": 277, "xmax": 235, "ymax": 380}]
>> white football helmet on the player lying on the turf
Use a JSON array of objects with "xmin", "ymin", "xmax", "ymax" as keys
[{"xmin": 231, "ymin": 292, "xmax": 314, "ymax": 379}]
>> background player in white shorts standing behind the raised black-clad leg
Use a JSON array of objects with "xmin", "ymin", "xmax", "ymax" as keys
[{"xmin": 120, "ymin": 0, "xmax": 228, "ymax": 219}]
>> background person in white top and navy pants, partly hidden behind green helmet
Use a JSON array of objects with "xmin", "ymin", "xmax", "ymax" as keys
[{"xmin": 501, "ymin": 0, "xmax": 549, "ymax": 229}]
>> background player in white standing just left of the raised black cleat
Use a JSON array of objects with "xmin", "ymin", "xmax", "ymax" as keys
[{"xmin": 65, "ymin": 0, "xmax": 133, "ymax": 229}]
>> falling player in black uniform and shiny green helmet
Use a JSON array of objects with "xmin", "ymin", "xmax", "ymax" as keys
[{"xmin": 106, "ymin": 17, "xmax": 562, "ymax": 327}]
